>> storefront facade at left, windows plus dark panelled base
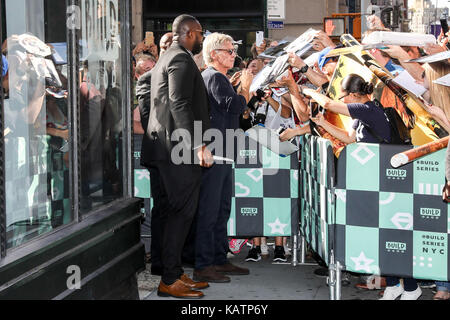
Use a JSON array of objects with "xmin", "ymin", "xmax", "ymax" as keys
[{"xmin": 0, "ymin": 0, "xmax": 145, "ymax": 299}]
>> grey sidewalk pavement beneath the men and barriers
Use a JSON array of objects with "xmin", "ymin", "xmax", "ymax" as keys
[{"xmin": 138, "ymin": 247, "xmax": 433, "ymax": 300}]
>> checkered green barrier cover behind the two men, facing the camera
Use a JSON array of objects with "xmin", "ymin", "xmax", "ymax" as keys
[{"xmin": 134, "ymin": 137, "xmax": 299, "ymax": 237}]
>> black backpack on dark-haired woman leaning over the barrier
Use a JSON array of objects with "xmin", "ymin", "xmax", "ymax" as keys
[{"xmin": 364, "ymin": 99, "xmax": 412, "ymax": 145}]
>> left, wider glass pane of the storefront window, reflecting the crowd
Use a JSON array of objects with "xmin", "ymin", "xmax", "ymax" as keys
[{"xmin": 2, "ymin": 0, "xmax": 73, "ymax": 248}]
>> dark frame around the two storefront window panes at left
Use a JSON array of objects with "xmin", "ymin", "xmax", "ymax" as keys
[{"xmin": 0, "ymin": 0, "xmax": 133, "ymax": 261}]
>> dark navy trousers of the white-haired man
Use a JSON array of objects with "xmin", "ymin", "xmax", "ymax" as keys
[{"xmin": 195, "ymin": 164, "xmax": 233, "ymax": 270}]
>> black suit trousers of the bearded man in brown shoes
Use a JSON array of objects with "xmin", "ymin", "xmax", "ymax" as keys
[{"xmin": 151, "ymin": 161, "xmax": 202, "ymax": 285}]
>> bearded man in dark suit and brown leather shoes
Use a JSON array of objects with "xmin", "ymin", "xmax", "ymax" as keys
[{"xmin": 141, "ymin": 15, "xmax": 212, "ymax": 298}]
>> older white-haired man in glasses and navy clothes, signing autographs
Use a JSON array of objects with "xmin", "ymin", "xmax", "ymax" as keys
[{"xmin": 194, "ymin": 33, "xmax": 253, "ymax": 283}]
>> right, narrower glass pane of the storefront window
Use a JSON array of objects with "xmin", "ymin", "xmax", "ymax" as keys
[{"xmin": 80, "ymin": 0, "xmax": 125, "ymax": 213}]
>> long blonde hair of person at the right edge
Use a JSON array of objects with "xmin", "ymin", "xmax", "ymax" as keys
[{"xmin": 424, "ymin": 62, "xmax": 450, "ymax": 119}]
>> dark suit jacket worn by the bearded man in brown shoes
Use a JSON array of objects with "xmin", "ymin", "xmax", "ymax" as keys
[{"xmin": 141, "ymin": 41, "xmax": 210, "ymax": 166}]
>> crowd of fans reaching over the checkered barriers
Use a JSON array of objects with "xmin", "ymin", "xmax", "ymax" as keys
[{"xmin": 133, "ymin": 16, "xmax": 450, "ymax": 300}]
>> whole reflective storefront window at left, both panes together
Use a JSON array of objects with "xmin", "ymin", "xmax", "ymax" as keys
[{"xmin": 0, "ymin": 0, "xmax": 131, "ymax": 249}]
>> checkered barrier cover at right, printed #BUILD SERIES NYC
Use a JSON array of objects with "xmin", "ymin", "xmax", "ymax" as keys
[{"xmin": 301, "ymin": 137, "xmax": 450, "ymax": 281}]
